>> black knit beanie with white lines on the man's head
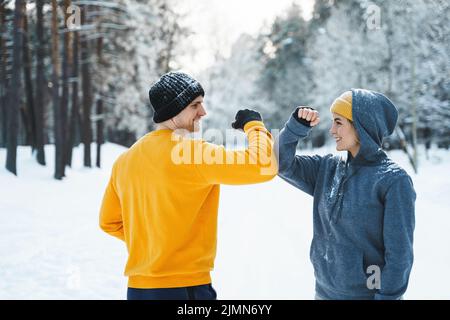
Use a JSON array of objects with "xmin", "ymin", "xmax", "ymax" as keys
[{"xmin": 148, "ymin": 72, "xmax": 205, "ymax": 123}]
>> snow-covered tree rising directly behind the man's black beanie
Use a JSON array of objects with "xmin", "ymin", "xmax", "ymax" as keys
[{"xmin": 98, "ymin": 0, "xmax": 192, "ymax": 146}]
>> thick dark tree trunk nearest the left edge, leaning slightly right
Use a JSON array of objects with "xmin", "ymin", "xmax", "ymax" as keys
[{"xmin": 6, "ymin": 0, "xmax": 24, "ymax": 175}]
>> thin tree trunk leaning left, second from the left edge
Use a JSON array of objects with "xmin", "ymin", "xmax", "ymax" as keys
[{"xmin": 23, "ymin": 6, "xmax": 36, "ymax": 151}]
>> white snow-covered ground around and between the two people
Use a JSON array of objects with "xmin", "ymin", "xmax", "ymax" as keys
[{"xmin": 0, "ymin": 144, "xmax": 450, "ymax": 299}]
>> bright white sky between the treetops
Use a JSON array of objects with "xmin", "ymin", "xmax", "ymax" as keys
[{"xmin": 174, "ymin": 0, "xmax": 314, "ymax": 74}]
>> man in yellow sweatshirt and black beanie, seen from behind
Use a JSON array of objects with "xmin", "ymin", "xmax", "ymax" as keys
[{"xmin": 100, "ymin": 72, "xmax": 277, "ymax": 300}]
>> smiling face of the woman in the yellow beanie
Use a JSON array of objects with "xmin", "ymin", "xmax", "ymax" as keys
[{"xmin": 330, "ymin": 112, "xmax": 360, "ymax": 157}]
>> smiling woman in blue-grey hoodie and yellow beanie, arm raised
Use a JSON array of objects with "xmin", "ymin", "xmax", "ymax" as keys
[{"xmin": 275, "ymin": 89, "xmax": 416, "ymax": 299}]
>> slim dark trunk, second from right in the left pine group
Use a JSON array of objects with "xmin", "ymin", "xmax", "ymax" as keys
[{"xmin": 80, "ymin": 6, "xmax": 92, "ymax": 167}]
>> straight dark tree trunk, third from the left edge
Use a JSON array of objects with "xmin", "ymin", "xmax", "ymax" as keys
[{"xmin": 35, "ymin": 0, "xmax": 47, "ymax": 166}]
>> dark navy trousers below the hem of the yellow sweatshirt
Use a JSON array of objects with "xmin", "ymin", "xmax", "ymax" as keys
[{"xmin": 127, "ymin": 284, "xmax": 217, "ymax": 300}]
